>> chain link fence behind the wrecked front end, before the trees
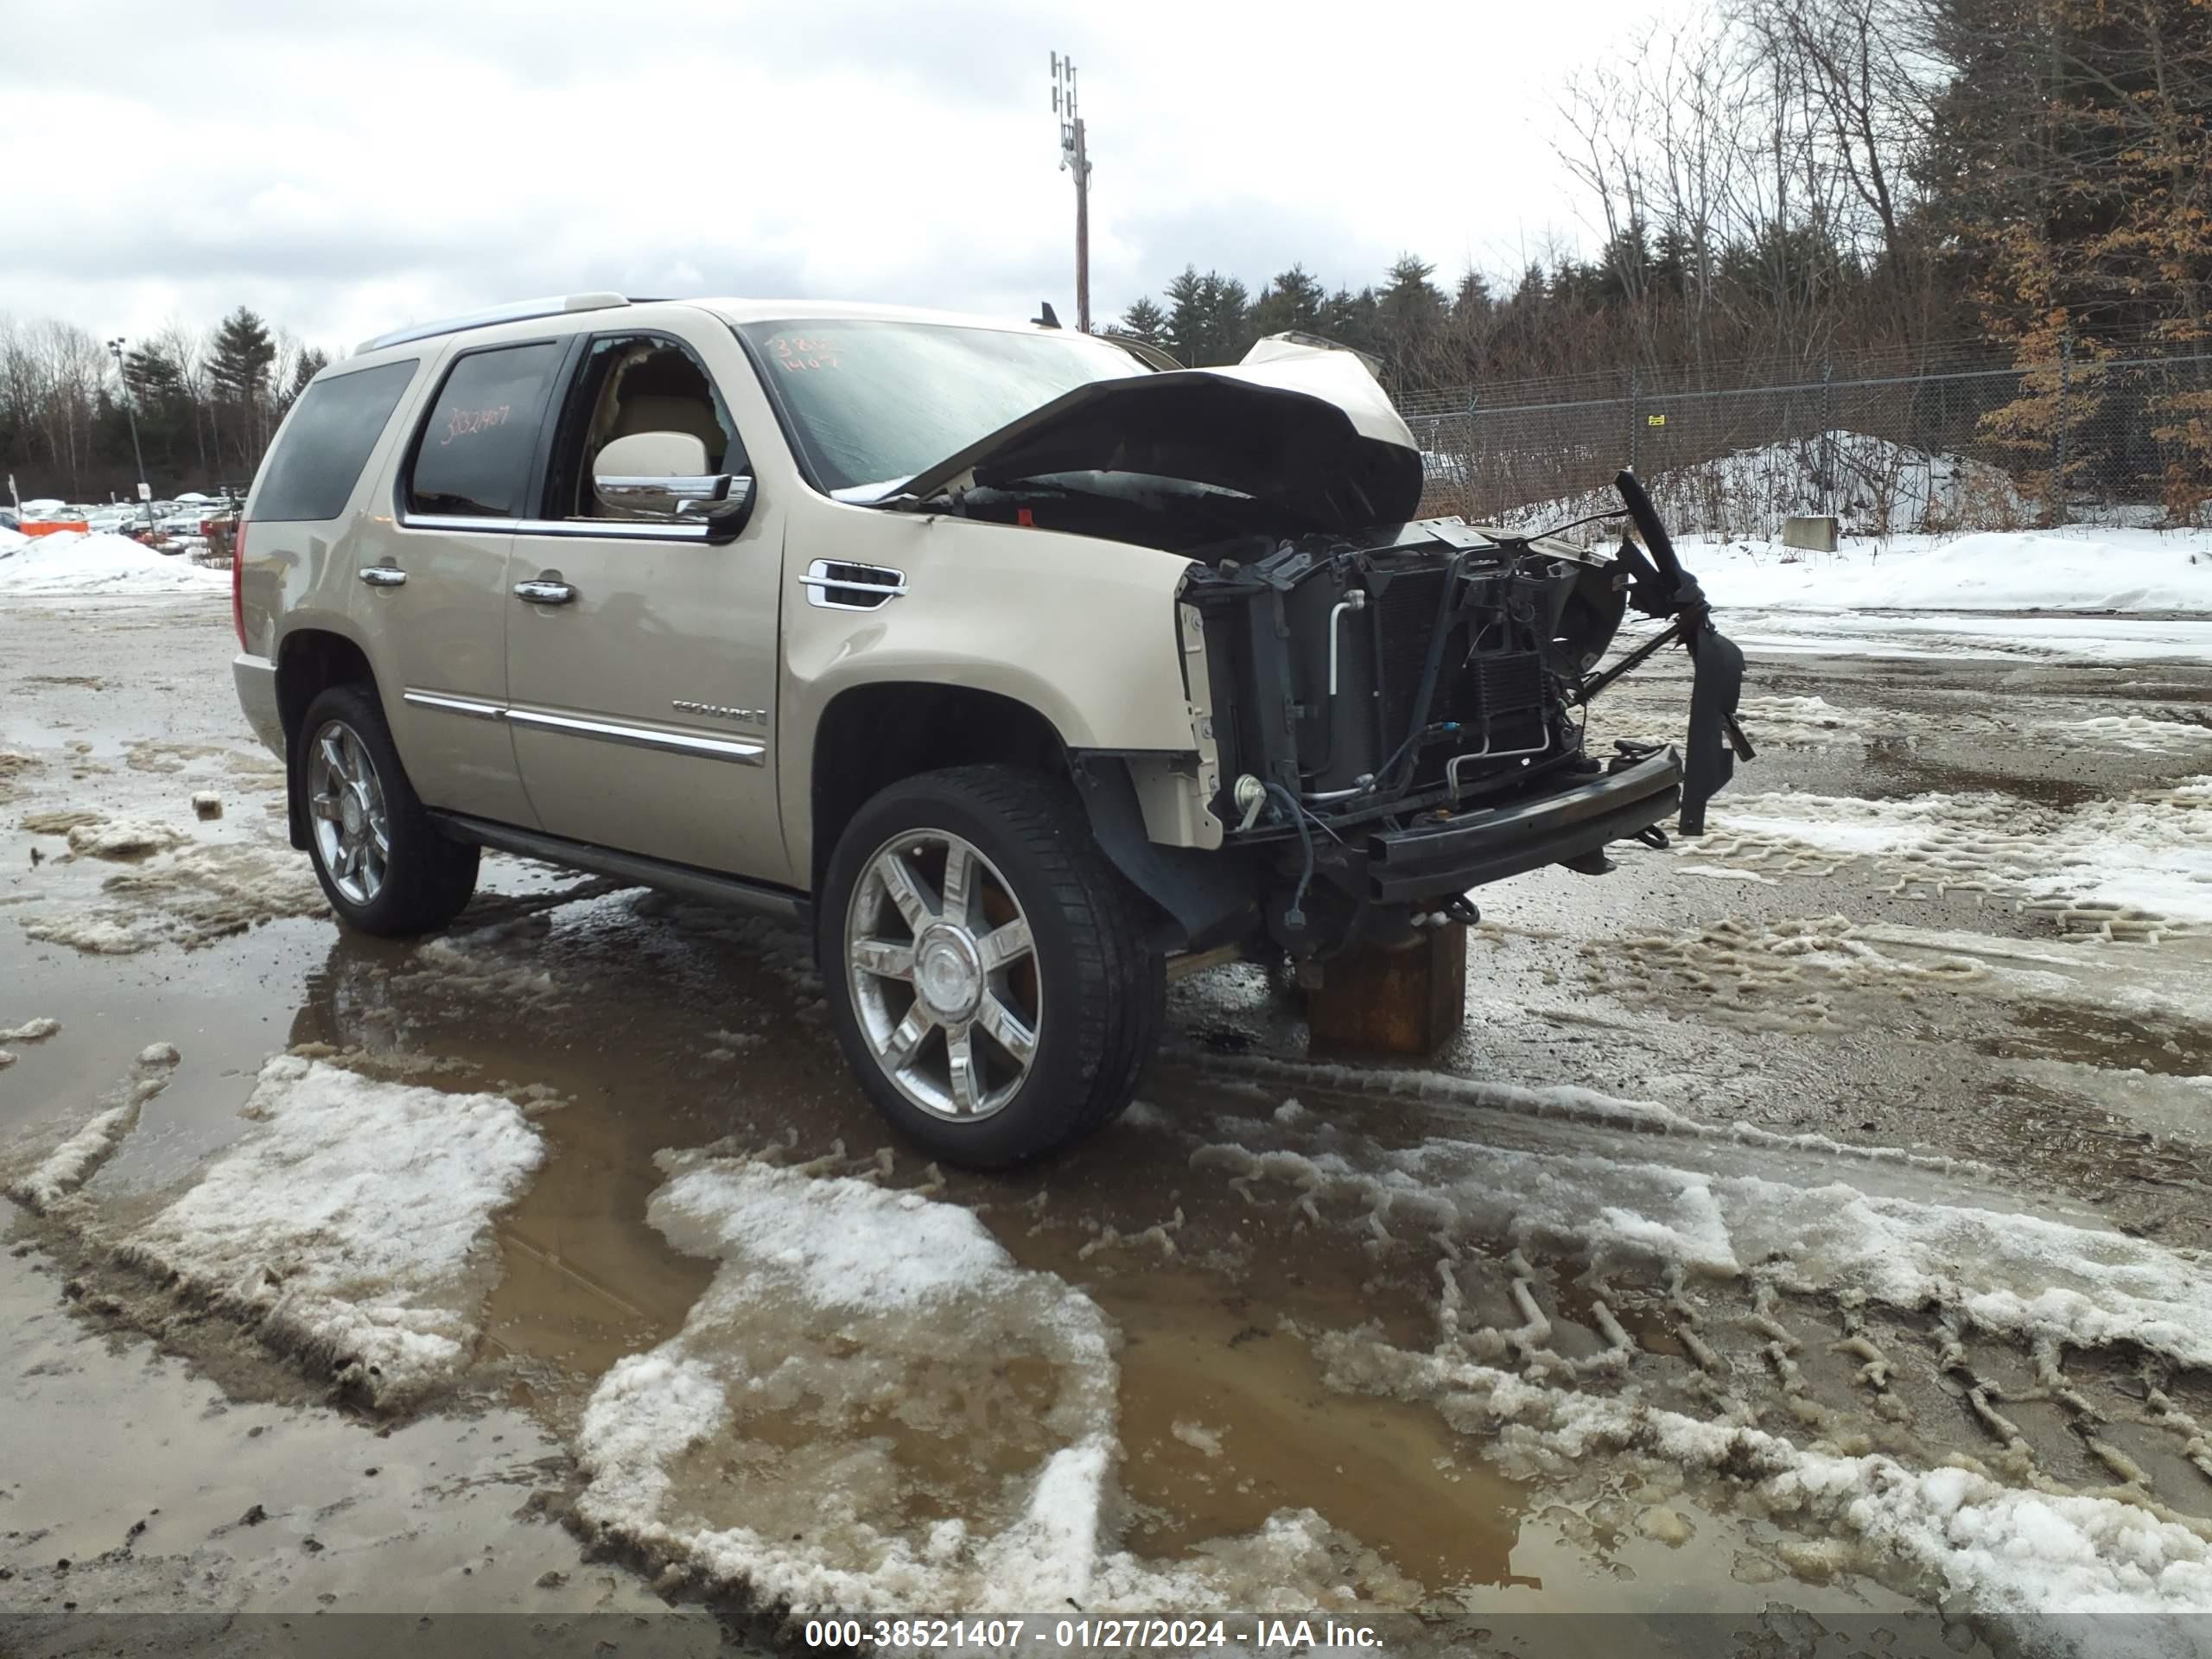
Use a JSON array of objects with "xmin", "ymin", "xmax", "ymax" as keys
[{"xmin": 1398, "ymin": 343, "xmax": 2212, "ymax": 537}]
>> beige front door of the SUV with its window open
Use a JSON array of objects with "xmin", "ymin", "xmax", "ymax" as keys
[{"xmin": 506, "ymin": 327, "xmax": 790, "ymax": 882}]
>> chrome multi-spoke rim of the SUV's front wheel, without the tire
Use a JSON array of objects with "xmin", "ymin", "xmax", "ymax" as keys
[{"xmin": 845, "ymin": 830, "xmax": 1044, "ymax": 1122}]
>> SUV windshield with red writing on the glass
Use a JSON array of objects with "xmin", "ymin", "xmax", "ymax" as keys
[{"xmin": 739, "ymin": 321, "xmax": 1148, "ymax": 500}]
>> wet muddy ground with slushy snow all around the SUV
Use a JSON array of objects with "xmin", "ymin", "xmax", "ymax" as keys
[{"xmin": 0, "ymin": 597, "xmax": 2212, "ymax": 1650}]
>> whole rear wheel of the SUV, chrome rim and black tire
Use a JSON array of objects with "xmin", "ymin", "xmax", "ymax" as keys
[{"xmin": 292, "ymin": 686, "xmax": 478, "ymax": 936}]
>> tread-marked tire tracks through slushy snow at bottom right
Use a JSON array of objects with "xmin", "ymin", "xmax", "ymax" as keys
[{"xmin": 1157, "ymin": 1064, "xmax": 2212, "ymax": 1608}]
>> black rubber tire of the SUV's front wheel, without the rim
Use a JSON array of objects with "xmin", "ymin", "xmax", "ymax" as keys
[{"xmin": 814, "ymin": 766, "xmax": 1166, "ymax": 1168}]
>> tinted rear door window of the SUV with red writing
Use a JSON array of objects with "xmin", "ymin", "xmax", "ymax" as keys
[{"xmin": 407, "ymin": 340, "xmax": 566, "ymax": 518}]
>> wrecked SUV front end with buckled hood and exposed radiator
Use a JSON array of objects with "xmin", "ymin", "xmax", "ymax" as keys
[{"xmin": 876, "ymin": 340, "xmax": 1752, "ymax": 960}]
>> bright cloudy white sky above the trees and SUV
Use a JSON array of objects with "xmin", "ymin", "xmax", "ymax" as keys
[{"xmin": 0, "ymin": 0, "xmax": 1652, "ymax": 349}]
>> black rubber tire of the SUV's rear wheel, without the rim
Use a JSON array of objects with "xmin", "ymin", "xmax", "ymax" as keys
[{"xmin": 292, "ymin": 683, "xmax": 478, "ymax": 938}]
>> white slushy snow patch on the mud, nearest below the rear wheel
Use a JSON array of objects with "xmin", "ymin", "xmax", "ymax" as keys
[{"xmin": 119, "ymin": 1055, "xmax": 544, "ymax": 1405}]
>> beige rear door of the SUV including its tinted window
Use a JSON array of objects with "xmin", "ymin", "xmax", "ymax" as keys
[{"xmin": 385, "ymin": 339, "xmax": 573, "ymax": 827}]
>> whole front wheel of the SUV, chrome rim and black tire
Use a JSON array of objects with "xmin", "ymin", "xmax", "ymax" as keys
[{"xmin": 817, "ymin": 766, "xmax": 1166, "ymax": 1168}]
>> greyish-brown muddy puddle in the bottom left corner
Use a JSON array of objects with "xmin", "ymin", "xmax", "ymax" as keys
[{"xmin": 0, "ymin": 1252, "xmax": 716, "ymax": 1617}]
